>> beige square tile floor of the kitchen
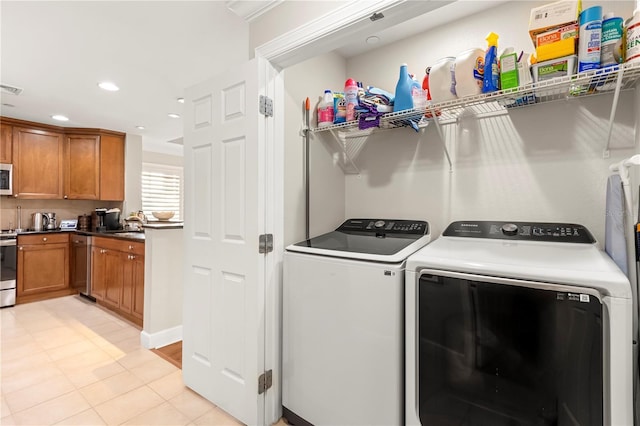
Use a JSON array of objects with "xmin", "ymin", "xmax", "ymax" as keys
[{"xmin": 0, "ymin": 296, "xmax": 284, "ymax": 425}]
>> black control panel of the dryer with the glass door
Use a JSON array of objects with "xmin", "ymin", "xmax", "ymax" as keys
[{"xmin": 442, "ymin": 221, "xmax": 596, "ymax": 244}]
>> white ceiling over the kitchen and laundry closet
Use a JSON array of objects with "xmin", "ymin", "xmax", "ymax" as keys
[{"xmin": 0, "ymin": 0, "xmax": 504, "ymax": 155}]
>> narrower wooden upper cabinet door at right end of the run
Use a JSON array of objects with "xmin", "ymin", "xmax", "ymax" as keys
[{"xmin": 64, "ymin": 134, "xmax": 100, "ymax": 200}]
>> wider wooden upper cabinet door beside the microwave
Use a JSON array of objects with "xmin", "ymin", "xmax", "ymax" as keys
[{"xmin": 13, "ymin": 127, "xmax": 64, "ymax": 199}]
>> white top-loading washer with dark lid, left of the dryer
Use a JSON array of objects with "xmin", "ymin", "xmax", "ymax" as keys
[{"xmin": 282, "ymin": 219, "xmax": 430, "ymax": 425}]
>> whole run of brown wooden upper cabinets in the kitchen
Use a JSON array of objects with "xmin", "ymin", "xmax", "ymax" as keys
[{"xmin": 0, "ymin": 117, "xmax": 125, "ymax": 201}]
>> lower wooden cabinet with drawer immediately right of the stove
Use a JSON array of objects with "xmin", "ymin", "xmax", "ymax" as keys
[{"xmin": 16, "ymin": 233, "xmax": 71, "ymax": 303}]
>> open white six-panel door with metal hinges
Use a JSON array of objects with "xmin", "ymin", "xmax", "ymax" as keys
[{"xmin": 182, "ymin": 60, "xmax": 267, "ymax": 425}]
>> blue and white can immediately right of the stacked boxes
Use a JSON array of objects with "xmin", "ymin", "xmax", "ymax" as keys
[{"xmin": 578, "ymin": 6, "xmax": 602, "ymax": 72}]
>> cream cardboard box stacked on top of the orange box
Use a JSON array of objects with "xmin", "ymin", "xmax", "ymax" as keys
[{"xmin": 529, "ymin": 0, "xmax": 582, "ymax": 42}]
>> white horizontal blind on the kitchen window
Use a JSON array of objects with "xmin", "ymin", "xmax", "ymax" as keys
[{"xmin": 142, "ymin": 163, "xmax": 183, "ymax": 220}]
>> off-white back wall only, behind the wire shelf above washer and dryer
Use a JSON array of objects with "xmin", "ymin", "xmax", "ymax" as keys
[{"xmin": 328, "ymin": 2, "xmax": 639, "ymax": 242}]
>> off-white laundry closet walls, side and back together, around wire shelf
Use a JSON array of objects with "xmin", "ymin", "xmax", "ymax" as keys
[{"xmin": 284, "ymin": 1, "xmax": 640, "ymax": 247}]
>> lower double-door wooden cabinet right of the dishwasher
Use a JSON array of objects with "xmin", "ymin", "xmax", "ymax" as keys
[{"xmin": 91, "ymin": 237, "xmax": 144, "ymax": 326}]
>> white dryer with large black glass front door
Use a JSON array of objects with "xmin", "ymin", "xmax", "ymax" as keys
[{"xmin": 405, "ymin": 221, "xmax": 633, "ymax": 426}]
